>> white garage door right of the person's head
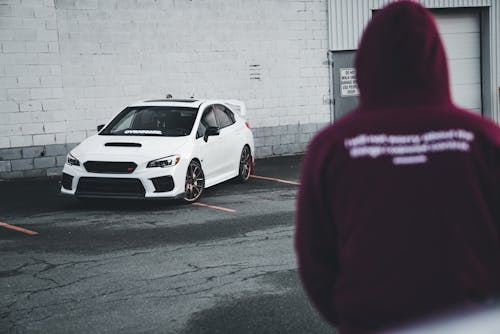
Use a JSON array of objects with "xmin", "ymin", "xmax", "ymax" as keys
[{"xmin": 433, "ymin": 9, "xmax": 481, "ymax": 113}]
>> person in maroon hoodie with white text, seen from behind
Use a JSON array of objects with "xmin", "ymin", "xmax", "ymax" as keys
[{"xmin": 295, "ymin": 1, "xmax": 500, "ymax": 334}]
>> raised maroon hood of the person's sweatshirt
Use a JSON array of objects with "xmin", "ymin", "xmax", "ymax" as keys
[{"xmin": 355, "ymin": 1, "xmax": 451, "ymax": 109}]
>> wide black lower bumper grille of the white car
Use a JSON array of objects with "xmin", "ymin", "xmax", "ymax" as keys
[{"xmin": 76, "ymin": 177, "xmax": 146, "ymax": 197}]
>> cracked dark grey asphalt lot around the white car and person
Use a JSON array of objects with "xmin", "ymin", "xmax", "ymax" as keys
[{"xmin": 0, "ymin": 156, "xmax": 335, "ymax": 334}]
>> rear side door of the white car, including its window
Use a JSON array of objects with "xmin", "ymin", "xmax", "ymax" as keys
[{"xmin": 214, "ymin": 104, "xmax": 242, "ymax": 173}]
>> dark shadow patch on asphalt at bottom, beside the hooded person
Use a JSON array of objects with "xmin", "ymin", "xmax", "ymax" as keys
[{"xmin": 182, "ymin": 270, "xmax": 336, "ymax": 334}]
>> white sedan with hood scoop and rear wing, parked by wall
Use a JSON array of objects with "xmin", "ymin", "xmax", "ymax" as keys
[{"xmin": 61, "ymin": 98, "xmax": 255, "ymax": 202}]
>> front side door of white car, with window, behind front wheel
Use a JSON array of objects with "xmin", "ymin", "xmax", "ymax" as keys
[{"xmin": 196, "ymin": 106, "xmax": 225, "ymax": 181}]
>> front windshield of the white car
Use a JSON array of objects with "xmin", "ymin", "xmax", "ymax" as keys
[{"xmin": 99, "ymin": 106, "xmax": 198, "ymax": 137}]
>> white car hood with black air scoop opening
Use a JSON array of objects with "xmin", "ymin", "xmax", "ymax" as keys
[{"xmin": 71, "ymin": 135, "xmax": 191, "ymax": 163}]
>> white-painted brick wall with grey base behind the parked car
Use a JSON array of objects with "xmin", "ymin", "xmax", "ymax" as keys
[{"xmin": 0, "ymin": 0, "xmax": 330, "ymax": 178}]
